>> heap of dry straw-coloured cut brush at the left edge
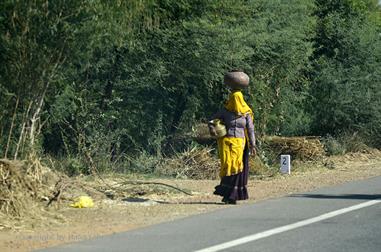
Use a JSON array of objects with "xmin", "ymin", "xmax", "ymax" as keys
[{"xmin": 0, "ymin": 157, "xmax": 64, "ymax": 229}]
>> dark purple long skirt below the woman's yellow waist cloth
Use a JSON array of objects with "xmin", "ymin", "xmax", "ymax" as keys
[{"xmin": 214, "ymin": 143, "xmax": 249, "ymax": 201}]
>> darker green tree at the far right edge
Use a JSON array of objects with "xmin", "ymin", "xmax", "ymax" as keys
[{"xmin": 310, "ymin": 1, "xmax": 381, "ymax": 146}]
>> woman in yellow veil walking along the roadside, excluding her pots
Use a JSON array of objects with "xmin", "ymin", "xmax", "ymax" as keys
[{"xmin": 209, "ymin": 72, "xmax": 256, "ymax": 204}]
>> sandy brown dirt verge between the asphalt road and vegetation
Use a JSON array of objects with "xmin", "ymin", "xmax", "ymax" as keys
[{"xmin": 0, "ymin": 151, "xmax": 381, "ymax": 251}]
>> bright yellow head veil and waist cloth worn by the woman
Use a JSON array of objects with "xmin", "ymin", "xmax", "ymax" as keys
[{"xmin": 217, "ymin": 91, "xmax": 254, "ymax": 178}]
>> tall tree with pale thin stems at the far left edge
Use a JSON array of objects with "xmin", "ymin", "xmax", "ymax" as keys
[{"xmin": 0, "ymin": 0, "xmax": 100, "ymax": 157}]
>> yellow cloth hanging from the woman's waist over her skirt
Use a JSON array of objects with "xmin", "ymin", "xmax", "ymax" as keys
[{"xmin": 217, "ymin": 137, "xmax": 245, "ymax": 178}]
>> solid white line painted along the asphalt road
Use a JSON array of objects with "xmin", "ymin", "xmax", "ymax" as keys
[{"xmin": 195, "ymin": 200, "xmax": 381, "ymax": 252}]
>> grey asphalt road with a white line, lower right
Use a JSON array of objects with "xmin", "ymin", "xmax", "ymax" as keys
[{"xmin": 37, "ymin": 177, "xmax": 381, "ymax": 252}]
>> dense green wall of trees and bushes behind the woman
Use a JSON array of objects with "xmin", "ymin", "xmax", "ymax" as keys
[{"xmin": 0, "ymin": 0, "xmax": 381, "ymax": 173}]
